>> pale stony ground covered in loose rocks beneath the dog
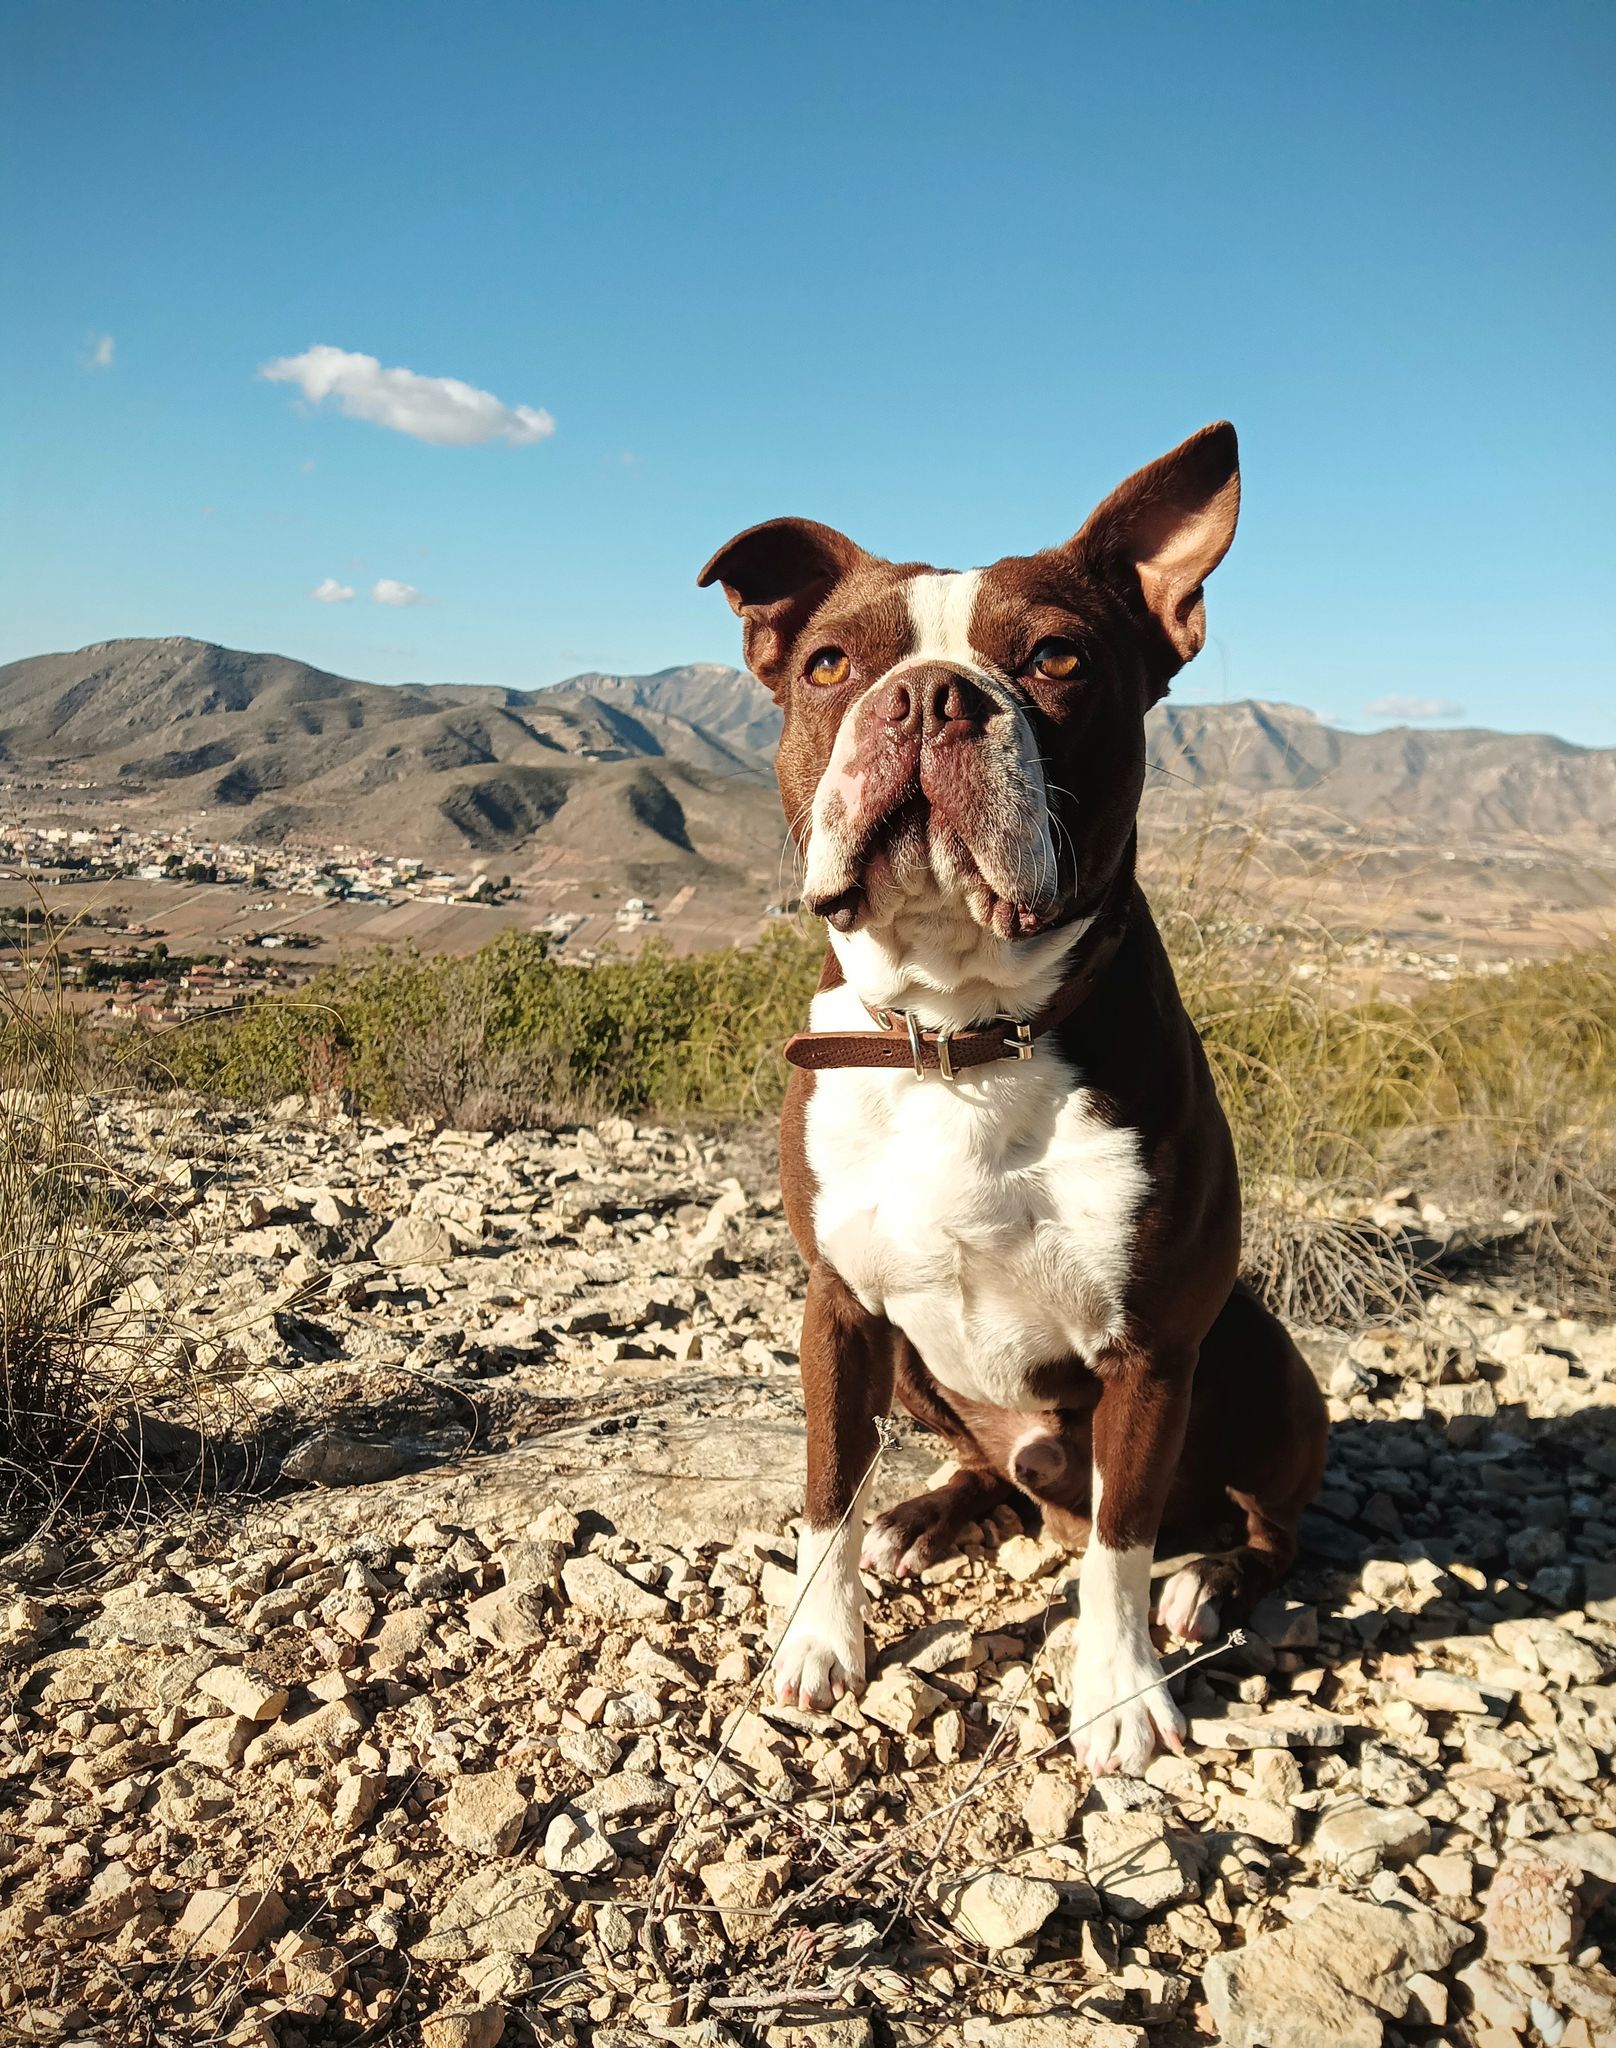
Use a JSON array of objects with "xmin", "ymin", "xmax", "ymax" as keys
[{"xmin": 0, "ymin": 1108, "xmax": 1616, "ymax": 2048}]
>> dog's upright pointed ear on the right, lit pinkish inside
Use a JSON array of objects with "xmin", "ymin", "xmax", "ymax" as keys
[{"xmin": 1065, "ymin": 420, "xmax": 1239, "ymax": 668}]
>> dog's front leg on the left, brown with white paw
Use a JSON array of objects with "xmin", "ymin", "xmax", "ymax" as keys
[{"xmin": 774, "ymin": 1260, "xmax": 893, "ymax": 1708}]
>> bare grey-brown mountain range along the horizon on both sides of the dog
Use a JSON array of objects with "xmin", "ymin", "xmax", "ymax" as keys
[{"xmin": 0, "ymin": 637, "xmax": 1616, "ymax": 889}]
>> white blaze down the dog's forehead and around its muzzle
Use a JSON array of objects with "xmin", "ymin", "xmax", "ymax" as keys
[{"xmin": 803, "ymin": 569, "xmax": 1057, "ymax": 937}]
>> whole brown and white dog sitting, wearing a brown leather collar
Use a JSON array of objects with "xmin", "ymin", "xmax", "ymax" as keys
[{"xmin": 700, "ymin": 426, "xmax": 1325, "ymax": 1772}]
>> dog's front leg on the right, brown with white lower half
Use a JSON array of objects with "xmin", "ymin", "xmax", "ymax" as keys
[{"xmin": 1071, "ymin": 1346, "xmax": 1194, "ymax": 1778}]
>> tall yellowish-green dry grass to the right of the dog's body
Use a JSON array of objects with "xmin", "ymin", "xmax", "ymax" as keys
[{"xmin": 1155, "ymin": 813, "xmax": 1616, "ymax": 1327}]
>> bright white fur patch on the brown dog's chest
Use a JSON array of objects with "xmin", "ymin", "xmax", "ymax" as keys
[{"xmin": 805, "ymin": 987, "xmax": 1145, "ymax": 1409}]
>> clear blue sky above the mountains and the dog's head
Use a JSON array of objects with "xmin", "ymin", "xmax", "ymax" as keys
[{"xmin": 0, "ymin": 0, "xmax": 1616, "ymax": 743}]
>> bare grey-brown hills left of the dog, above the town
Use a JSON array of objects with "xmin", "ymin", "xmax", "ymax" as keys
[{"xmin": 0, "ymin": 639, "xmax": 776, "ymax": 885}]
